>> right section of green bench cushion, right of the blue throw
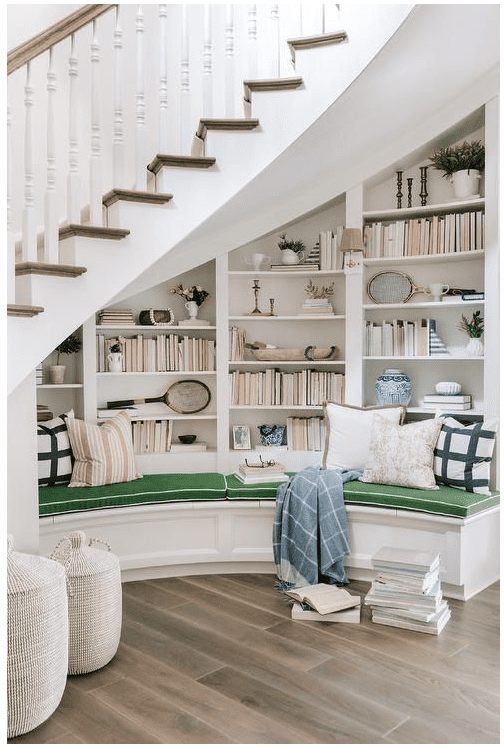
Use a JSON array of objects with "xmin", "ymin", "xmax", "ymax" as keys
[{"xmin": 344, "ymin": 480, "xmax": 500, "ymax": 517}]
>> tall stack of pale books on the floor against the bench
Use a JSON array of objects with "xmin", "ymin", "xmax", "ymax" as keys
[{"xmin": 364, "ymin": 547, "xmax": 450, "ymax": 636}]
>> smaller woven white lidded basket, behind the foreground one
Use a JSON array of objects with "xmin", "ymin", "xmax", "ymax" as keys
[{"xmin": 51, "ymin": 530, "xmax": 122, "ymax": 675}]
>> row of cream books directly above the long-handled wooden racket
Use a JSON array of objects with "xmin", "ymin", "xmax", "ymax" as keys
[{"xmin": 96, "ymin": 333, "xmax": 215, "ymax": 372}]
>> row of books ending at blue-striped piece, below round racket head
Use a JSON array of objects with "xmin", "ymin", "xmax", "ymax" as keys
[{"xmin": 364, "ymin": 319, "xmax": 448, "ymax": 356}]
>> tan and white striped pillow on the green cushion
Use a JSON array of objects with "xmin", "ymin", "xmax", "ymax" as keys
[{"xmin": 67, "ymin": 411, "xmax": 142, "ymax": 488}]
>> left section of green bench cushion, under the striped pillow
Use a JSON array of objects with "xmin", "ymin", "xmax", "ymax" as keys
[{"xmin": 39, "ymin": 473, "xmax": 226, "ymax": 516}]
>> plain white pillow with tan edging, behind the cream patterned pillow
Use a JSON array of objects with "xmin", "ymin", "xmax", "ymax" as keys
[{"xmin": 323, "ymin": 402, "xmax": 406, "ymax": 470}]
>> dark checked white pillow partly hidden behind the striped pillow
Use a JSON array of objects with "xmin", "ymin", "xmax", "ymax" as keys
[{"xmin": 37, "ymin": 410, "xmax": 74, "ymax": 486}]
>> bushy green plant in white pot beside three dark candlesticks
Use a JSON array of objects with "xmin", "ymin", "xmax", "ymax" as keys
[{"xmin": 430, "ymin": 140, "xmax": 485, "ymax": 197}]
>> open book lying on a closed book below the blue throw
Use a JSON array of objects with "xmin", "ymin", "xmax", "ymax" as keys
[{"xmin": 285, "ymin": 582, "xmax": 361, "ymax": 623}]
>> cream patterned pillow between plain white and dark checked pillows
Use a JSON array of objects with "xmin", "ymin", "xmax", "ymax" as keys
[{"xmin": 360, "ymin": 413, "xmax": 443, "ymax": 490}]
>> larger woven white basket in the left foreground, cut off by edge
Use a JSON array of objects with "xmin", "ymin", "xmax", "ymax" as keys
[{"xmin": 7, "ymin": 535, "xmax": 68, "ymax": 738}]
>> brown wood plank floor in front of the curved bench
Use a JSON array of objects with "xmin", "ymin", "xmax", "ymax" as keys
[{"xmin": 8, "ymin": 574, "xmax": 499, "ymax": 744}]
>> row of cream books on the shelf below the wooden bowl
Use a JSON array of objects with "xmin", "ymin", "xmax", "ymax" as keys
[{"xmin": 229, "ymin": 369, "xmax": 345, "ymax": 405}]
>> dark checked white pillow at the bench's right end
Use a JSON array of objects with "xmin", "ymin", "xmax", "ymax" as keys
[{"xmin": 434, "ymin": 418, "xmax": 497, "ymax": 493}]
